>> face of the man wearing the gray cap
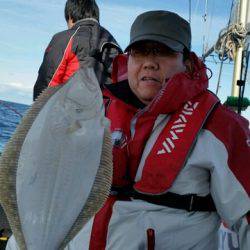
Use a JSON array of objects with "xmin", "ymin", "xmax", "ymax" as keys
[{"xmin": 128, "ymin": 41, "xmax": 186, "ymax": 105}]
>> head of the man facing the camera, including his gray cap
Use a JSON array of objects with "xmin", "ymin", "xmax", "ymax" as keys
[{"xmin": 125, "ymin": 11, "xmax": 191, "ymax": 104}]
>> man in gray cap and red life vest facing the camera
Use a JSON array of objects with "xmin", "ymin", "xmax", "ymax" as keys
[{"xmin": 6, "ymin": 11, "xmax": 250, "ymax": 250}]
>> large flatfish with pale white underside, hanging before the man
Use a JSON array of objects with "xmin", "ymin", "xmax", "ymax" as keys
[{"xmin": 0, "ymin": 68, "xmax": 112, "ymax": 250}]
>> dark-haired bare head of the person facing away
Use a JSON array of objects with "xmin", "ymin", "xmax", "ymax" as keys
[{"xmin": 64, "ymin": 0, "xmax": 99, "ymax": 28}]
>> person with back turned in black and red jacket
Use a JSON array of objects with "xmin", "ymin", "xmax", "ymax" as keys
[{"xmin": 33, "ymin": 0, "xmax": 121, "ymax": 100}]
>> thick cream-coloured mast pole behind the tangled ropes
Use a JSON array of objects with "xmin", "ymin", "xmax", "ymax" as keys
[{"xmin": 231, "ymin": 0, "xmax": 247, "ymax": 96}]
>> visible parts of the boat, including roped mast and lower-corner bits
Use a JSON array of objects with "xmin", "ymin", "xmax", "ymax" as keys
[{"xmin": 0, "ymin": 0, "xmax": 250, "ymax": 250}]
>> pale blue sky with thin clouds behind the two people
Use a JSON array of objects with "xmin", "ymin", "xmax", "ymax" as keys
[{"xmin": 0, "ymin": 0, "xmax": 250, "ymax": 119}]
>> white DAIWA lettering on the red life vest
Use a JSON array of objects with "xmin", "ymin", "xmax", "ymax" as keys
[{"xmin": 157, "ymin": 102, "xmax": 199, "ymax": 155}]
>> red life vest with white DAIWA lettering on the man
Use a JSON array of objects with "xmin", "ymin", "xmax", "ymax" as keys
[{"xmin": 103, "ymin": 51, "xmax": 218, "ymax": 191}]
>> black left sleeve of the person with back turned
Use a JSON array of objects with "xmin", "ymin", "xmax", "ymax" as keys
[{"xmin": 33, "ymin": 32, "xmax": 70, "ymax": 100}]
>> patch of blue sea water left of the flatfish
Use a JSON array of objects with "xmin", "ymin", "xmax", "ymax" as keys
[{"xmin": 0, "ymin": 100, "xmax": 29, "ymax": 152}]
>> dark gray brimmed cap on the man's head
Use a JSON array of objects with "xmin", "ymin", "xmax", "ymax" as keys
[{"xmin": 125, "ymin": 10, "xmax": 191, "ymax": 51}]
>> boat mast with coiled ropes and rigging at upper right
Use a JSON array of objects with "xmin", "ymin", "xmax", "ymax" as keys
[{"xmin": 202, "ymin": 0, "xmax": 250, "ymax": 114}]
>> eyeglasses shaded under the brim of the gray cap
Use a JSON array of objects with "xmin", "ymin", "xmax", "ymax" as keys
[{"xmin": 128, "ymin": 43, "xmax": 181, "ymax": 58}]
